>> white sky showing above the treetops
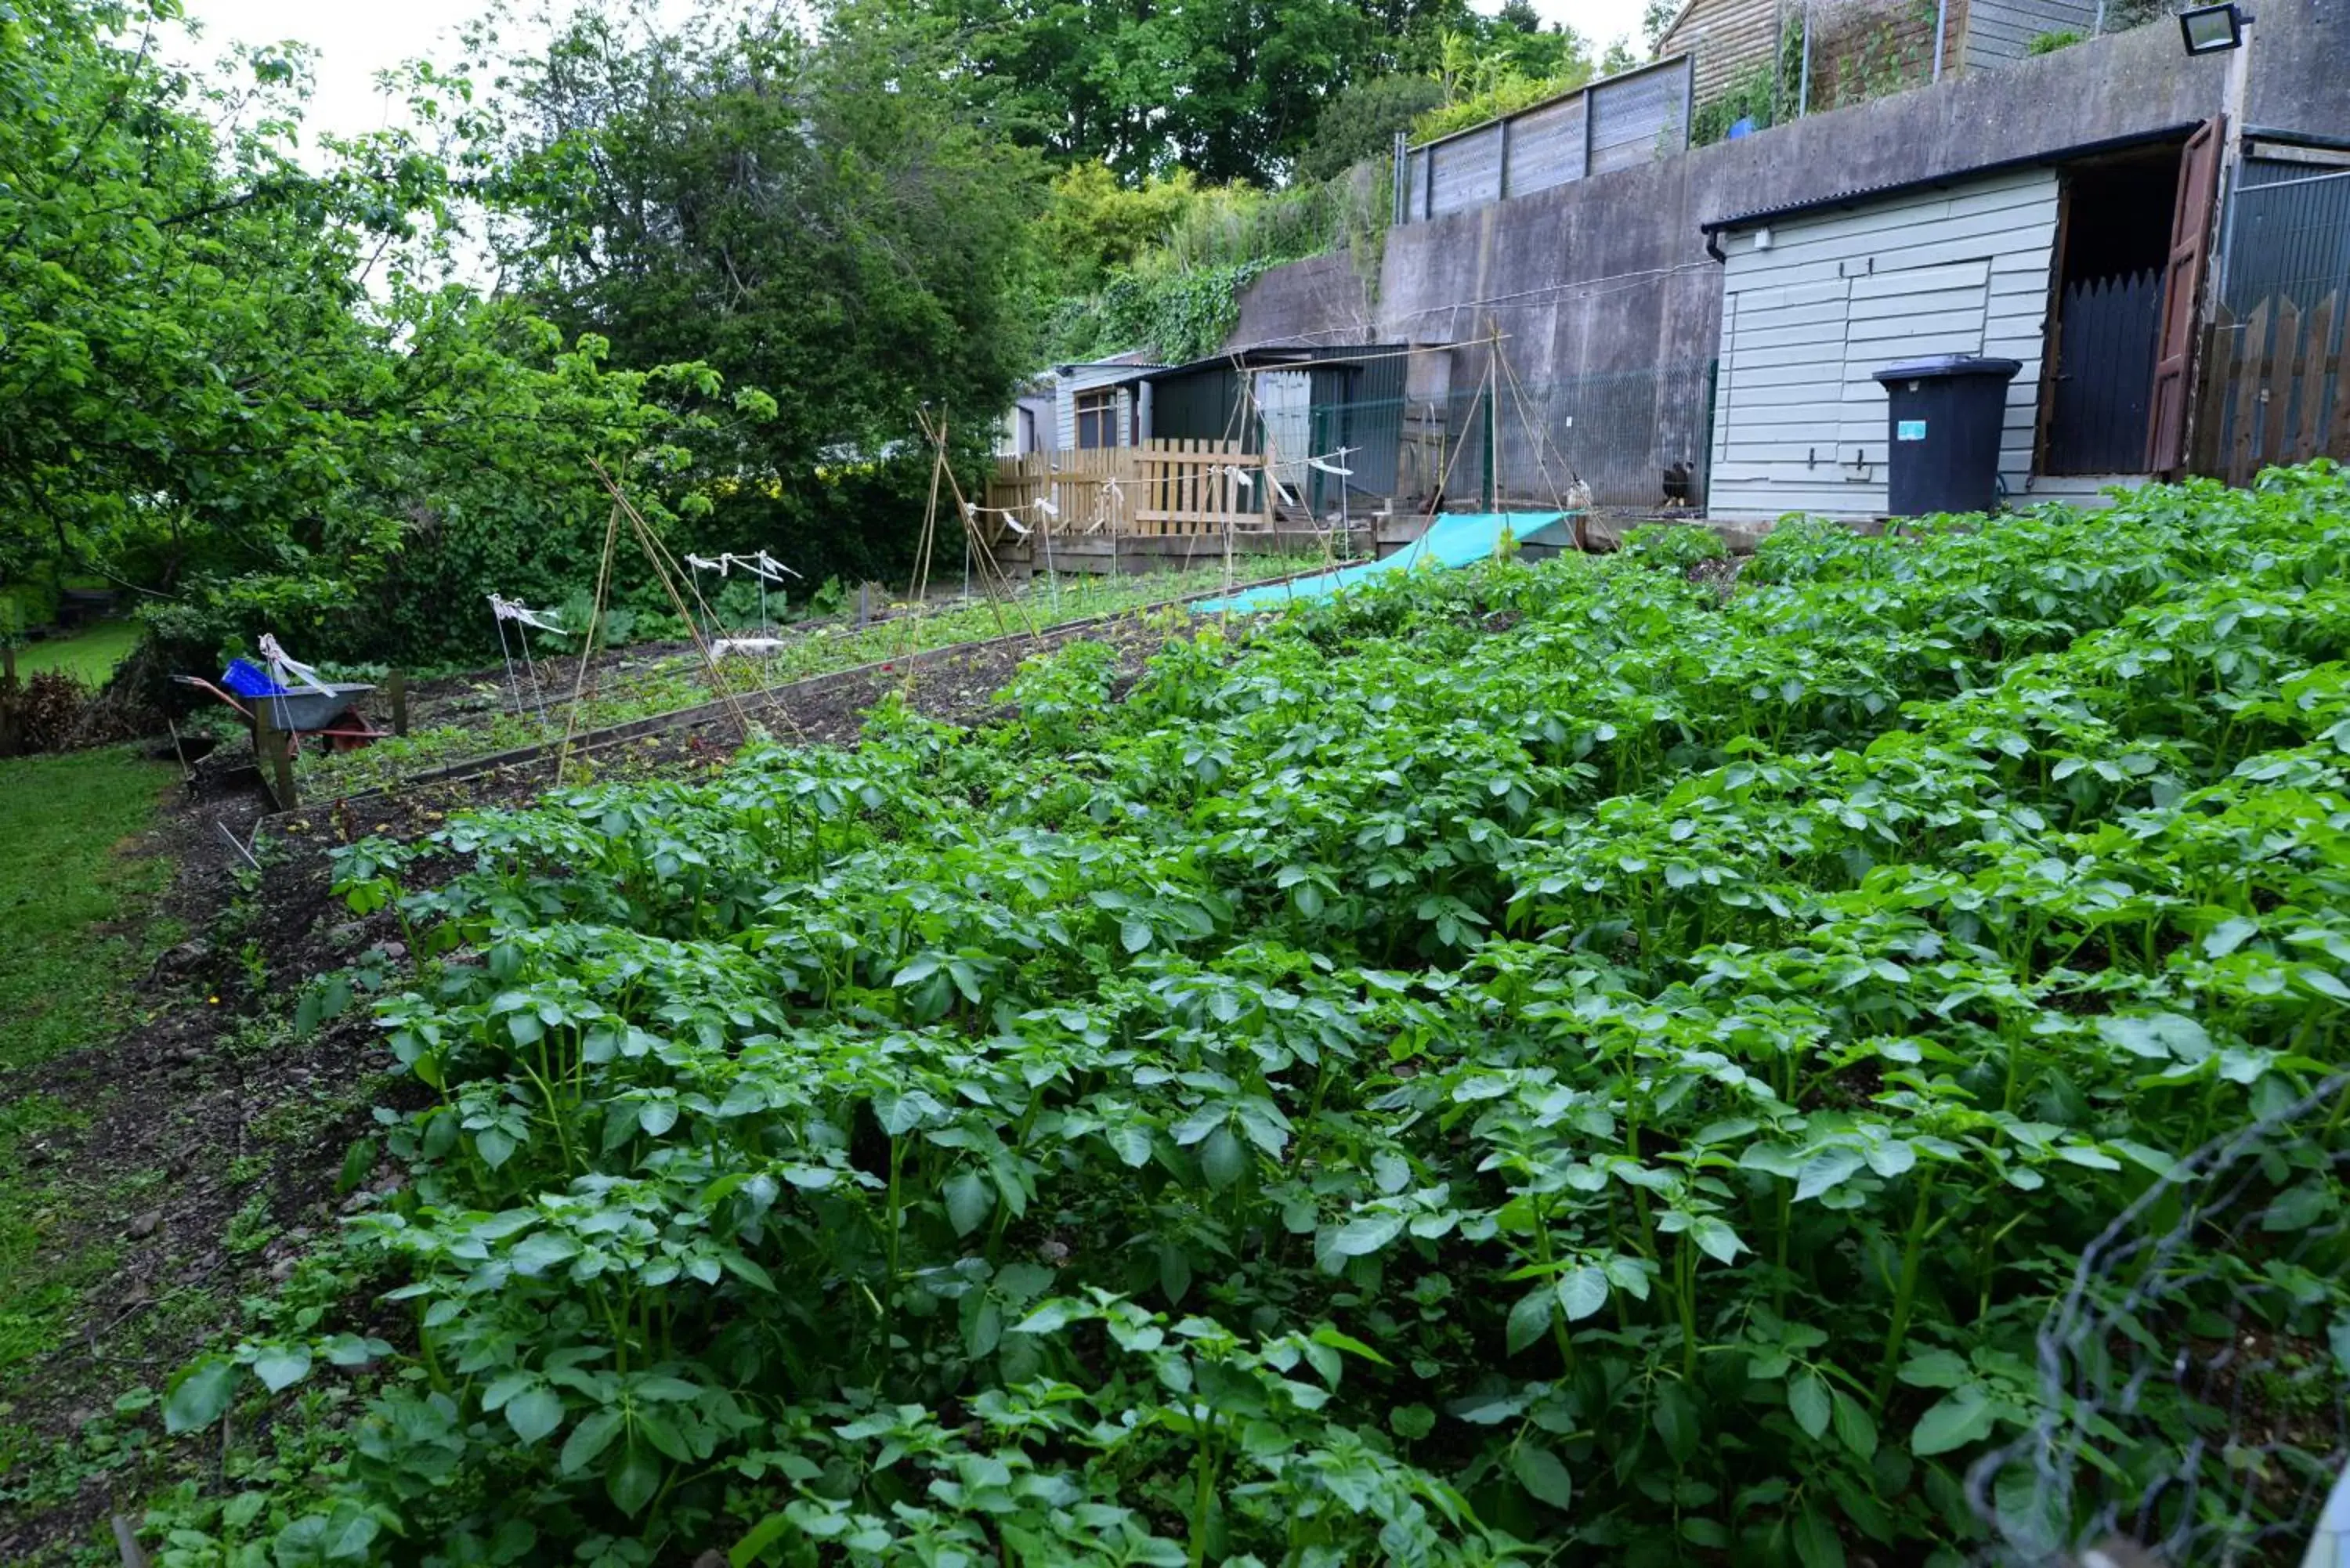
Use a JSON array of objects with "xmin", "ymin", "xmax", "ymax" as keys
[{"xmin": 174, "ymin": 0, "xmax": 1640, "ymax": 148}]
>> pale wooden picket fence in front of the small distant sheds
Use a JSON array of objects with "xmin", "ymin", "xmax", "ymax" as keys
[{"xmin": 987, "ymin": 439, "xmax": 1274, "ymax": 538}]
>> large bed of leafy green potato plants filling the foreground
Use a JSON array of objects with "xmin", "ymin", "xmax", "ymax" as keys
[{"xmin": 146, "ymin": 468, "xmax": 2350, "ymax": 1566}]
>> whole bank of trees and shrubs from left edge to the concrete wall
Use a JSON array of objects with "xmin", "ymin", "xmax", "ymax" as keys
[{"xmin": 0, "ymin": 0, "xmax": 1645, "ymax": 670}]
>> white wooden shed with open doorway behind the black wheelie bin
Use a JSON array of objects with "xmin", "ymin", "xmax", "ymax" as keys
[{"xmin": 1706, "ymin": 129, "xmax": 2209, "ymax": 519}]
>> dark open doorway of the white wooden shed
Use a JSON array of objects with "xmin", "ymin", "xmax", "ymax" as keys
[{"xmin": 2040, "ymin": 146, "xmax": 2178, "ymax": 475}]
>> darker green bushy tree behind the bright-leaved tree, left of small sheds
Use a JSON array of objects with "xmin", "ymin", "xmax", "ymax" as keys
[{"xmin": 479, "ymin": 5, "xmax": 1041, "ymax": 573}]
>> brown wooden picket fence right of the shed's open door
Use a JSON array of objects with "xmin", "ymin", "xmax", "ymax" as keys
[{"xmin": 2193, "ymin": 291, "xmax": 2350, "ymax": 484}]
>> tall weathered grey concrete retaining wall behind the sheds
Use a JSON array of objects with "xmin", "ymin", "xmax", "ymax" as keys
[{"xmin": 1231, "ymin": 0, "xmax": 2350, "ymax": 395}]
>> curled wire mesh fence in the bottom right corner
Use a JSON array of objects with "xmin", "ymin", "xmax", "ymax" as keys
[{"xmin": 1967, "ymin": 1081, "xmax": 2350, "ymax": 1568}]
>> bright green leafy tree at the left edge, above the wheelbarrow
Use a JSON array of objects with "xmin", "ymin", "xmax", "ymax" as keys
[{"xmin": 0, "ymin": 0, "xmax": 717, "ymax": 660}]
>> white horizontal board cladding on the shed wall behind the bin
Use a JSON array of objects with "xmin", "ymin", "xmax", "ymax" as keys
[{"xmin": 1711, "ymin": 169, "xmax": 2056, "ymax": 517}]
